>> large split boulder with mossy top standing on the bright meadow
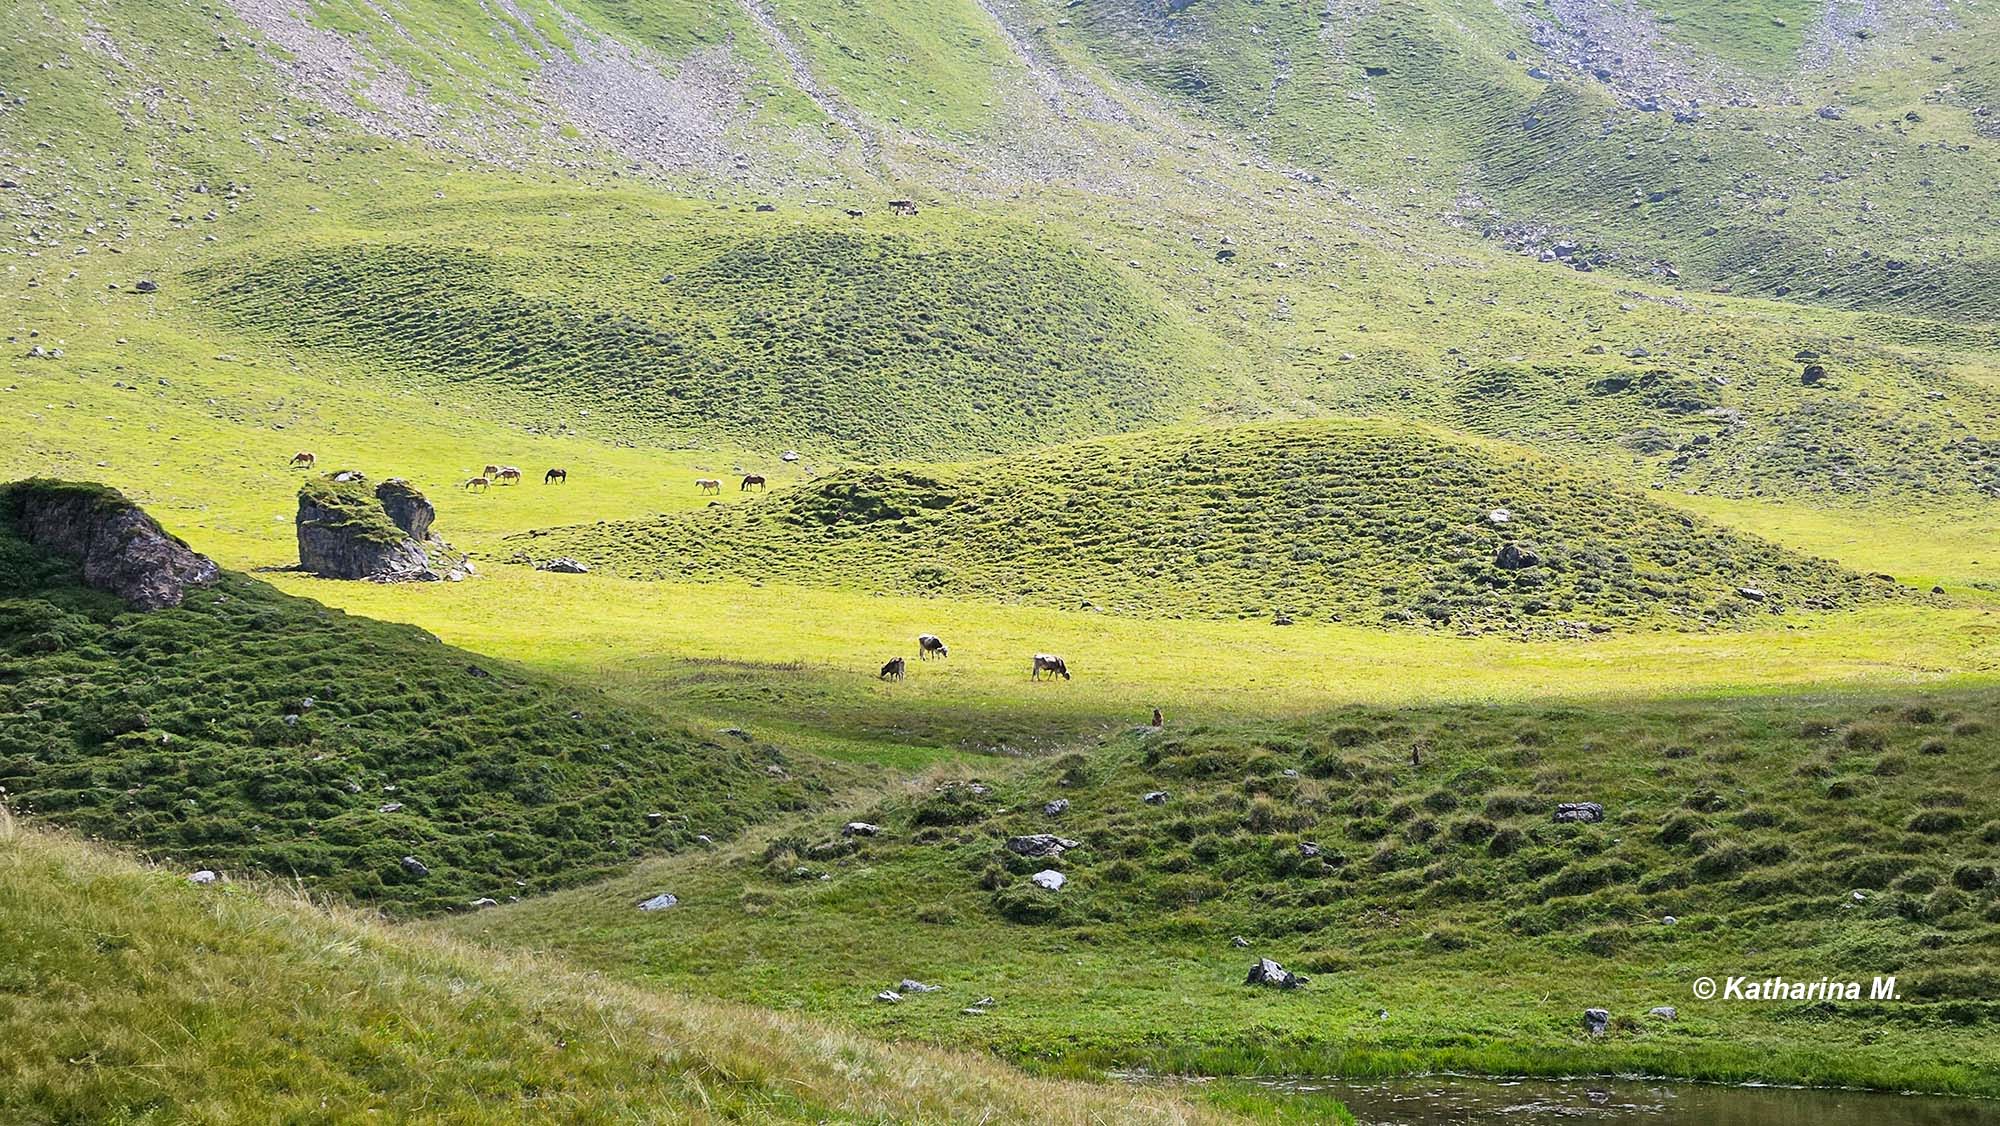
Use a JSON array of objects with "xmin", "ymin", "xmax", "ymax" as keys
[{"xmin": 298, "ymin": 472, "xmax": 466, "ymax": 582}]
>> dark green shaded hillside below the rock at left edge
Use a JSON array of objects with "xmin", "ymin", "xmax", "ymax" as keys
[{"xmin": 0, "ymin": 496, "xmax": 816, "ymax": 910}]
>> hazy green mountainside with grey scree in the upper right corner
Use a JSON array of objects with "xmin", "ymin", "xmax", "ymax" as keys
[{"xmin": 1056, "ymin": 0, "xmax": 2000, "ymax": 322}]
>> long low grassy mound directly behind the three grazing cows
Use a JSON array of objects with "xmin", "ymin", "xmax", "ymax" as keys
[{"xmin": 516, "ymin": 422, "xmax": 1888, "ymax": 632}]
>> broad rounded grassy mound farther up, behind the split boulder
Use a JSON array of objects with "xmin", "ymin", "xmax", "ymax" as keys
[{"xmin": 200, "ymin": 219, "xmax": 1200, "ymax": 458}]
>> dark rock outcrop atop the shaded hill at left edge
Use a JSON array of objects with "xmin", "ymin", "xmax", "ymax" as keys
[{"xmin": 0, "ymin": 480, "xmax": 222, "ymax": 610}]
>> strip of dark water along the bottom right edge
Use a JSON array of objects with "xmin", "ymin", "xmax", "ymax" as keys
[{"xmin": 1262, "ymin": 1076, "xmax": 2000, "ymax": 1126}]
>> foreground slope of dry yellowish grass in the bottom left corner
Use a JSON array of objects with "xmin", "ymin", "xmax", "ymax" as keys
[{"xmin": 0, "ymin": 814, "xmax": 1222, "ymax": 1124}]
